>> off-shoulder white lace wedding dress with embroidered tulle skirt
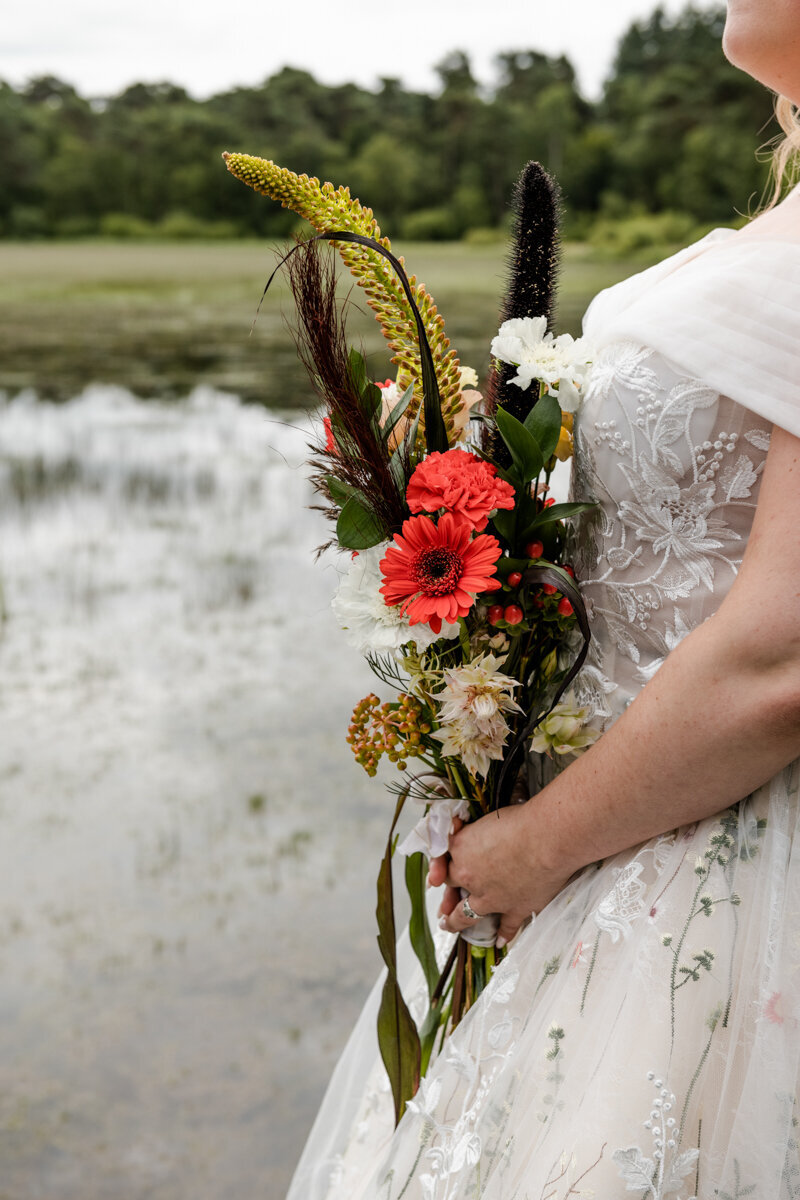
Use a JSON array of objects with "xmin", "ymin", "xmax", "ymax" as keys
[{"xmin": 289, "ymin": 234, "xmax": 800, "ymax": 1200}]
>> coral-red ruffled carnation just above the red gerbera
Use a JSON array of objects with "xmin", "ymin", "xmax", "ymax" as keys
[{"xmin": 405, "ymin": 450, "xmax": 513, "ymax": 533}]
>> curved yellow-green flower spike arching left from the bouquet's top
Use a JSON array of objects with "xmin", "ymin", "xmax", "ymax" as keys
[{"xmin": 223, "ymin": 154, "xmax": 462, "ymax": 440}]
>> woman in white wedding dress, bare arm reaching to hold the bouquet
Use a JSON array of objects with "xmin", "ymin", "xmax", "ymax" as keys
[{"xmin": 289, "ymin": 0, "xmax": 800, "ymax": 1200}]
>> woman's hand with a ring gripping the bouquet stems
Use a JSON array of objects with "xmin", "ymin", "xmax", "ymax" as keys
[{"xmin": 429, "ymin": 803, "xmax": 576, "ymax": 946}]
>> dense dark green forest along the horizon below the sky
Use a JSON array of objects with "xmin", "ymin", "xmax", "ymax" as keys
[{"xmin": 0, "ymin": 8, "xmax": 776, "ymax": 239}]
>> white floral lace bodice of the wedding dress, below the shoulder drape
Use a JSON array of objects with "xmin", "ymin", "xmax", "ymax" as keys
[{"xmin": 572, "ymin": 342, "xmax": 771, "ymax": 721}]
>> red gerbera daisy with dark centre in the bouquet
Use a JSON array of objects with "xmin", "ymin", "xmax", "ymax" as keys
[{"xmin": 380, "ymin": 512, "xmax": 500, "ymax": 634}]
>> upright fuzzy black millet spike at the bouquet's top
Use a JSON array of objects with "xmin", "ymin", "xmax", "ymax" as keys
[{"xmin": 487, "ymin": 162, "xmax": 561, "ymax": 466}]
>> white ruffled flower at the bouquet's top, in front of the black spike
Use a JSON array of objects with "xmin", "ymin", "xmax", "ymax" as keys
[{"xmin": 492, "ymin": 317, "xmax": 593, "ymax": 413}]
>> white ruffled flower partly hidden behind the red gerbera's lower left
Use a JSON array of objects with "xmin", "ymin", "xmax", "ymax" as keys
[{"xmin": 331, "ymin": 541, "xmax": 458, "ymax": 654}]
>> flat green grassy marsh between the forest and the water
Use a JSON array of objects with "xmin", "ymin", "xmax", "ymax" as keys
[{"xmin": 0, "ymin": 241, "xmax": 638, "ymax": 408}]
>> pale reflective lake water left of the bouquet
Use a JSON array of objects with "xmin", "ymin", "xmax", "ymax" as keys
[{"xmin": 0, "ymin": 386, "xmax": 390, "ymax": 1200}]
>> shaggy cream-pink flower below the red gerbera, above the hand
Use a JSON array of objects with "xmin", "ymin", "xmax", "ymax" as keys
[{"xmin": 433, "ymin": 654, "xmax": 522, "ymax": 776}]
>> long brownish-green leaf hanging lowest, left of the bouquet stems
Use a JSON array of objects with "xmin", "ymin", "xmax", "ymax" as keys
[{"xmin": 375, "ymin": 792, "xmax": 421, "ymax": 1122}]
